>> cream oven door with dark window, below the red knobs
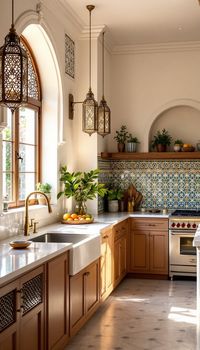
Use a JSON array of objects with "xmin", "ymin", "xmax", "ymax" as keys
[{"xmin": 170, "ymin": 230, "xmax": 196, "ymax": 266}]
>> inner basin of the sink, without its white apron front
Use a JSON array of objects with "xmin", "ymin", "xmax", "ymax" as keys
[{"xmin": 30, "ymin": 232, "xmax": 91, "ymax": 244}]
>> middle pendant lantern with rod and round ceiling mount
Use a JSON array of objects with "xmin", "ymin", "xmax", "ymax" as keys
[{"xmin": 82, "ymin": 5, "xmax": 98, "ymax": 136}]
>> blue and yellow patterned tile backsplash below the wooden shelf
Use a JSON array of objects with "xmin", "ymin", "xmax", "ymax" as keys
[{"xmin": 98, "ymin": 159, "xmax": 200, "ymax": 211}]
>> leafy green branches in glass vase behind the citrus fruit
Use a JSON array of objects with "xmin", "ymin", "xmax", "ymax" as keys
[{"xmin": 57, "ymin": 166, "xmax": 107, "ymax": 215}]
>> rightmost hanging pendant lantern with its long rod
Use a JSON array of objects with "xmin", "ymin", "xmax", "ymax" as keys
[{"xmin": 97, "ymin": 32, "xmax": 111, "ymax": 137}]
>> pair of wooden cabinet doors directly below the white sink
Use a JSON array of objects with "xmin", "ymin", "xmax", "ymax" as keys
[{"xmin": 70, "ymin": 259, "xmax": 100, "ymax": 336}]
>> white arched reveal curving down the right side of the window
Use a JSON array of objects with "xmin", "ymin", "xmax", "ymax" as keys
[{"xmin": 16, "ymin": 12, "xmax": 63, "ymax": 203}]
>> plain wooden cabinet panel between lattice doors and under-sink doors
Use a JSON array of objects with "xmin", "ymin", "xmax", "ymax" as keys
[{"xmin": 47, "ymin": 253, "xmax": 69, "ymax": 350}]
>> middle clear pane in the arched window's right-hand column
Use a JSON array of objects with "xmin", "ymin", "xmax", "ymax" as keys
[{"xmin": 19, "ymin": 144, "xmax": 35, "ymax": 172}]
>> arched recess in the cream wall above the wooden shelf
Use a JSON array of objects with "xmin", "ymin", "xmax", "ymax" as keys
[{"xmin": 147, "ymin": 99, "xmax": 200, "ymax": 150}]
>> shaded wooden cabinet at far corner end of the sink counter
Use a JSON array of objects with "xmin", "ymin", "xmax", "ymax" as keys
[{"xmin": 113, "ymin": 220, "xmax": 129, "ymax": 287}]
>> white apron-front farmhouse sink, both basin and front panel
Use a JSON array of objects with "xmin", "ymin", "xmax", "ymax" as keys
[{"xmin": 30, "ymin": 231, "xmax": 101, "ymax": 276}]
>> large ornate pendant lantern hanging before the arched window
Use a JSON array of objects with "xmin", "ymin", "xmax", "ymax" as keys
[{"xmin": 0, "ymin": 0, "xmax": 28, "ymax": 113}]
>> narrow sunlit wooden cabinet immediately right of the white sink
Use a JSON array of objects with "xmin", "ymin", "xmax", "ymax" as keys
[{"xmin": 100, "ymin": 229, "xmax": 114, "ymax": 300}]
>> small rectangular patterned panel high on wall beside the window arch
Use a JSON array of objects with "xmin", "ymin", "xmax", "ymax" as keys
[{"xmin": 65, "ymin": 34, "xmax": 75, "ymax": 78}]
